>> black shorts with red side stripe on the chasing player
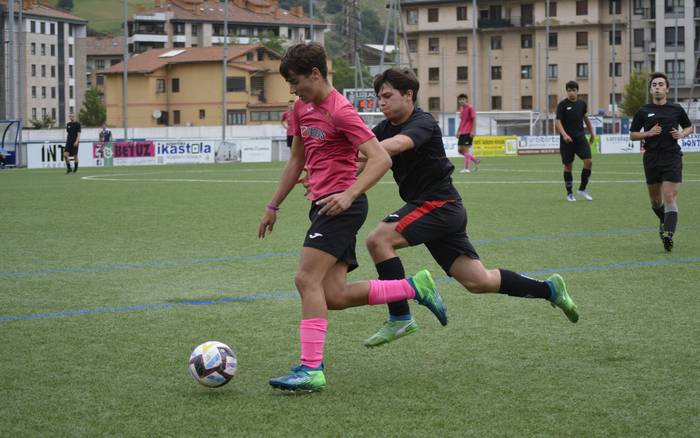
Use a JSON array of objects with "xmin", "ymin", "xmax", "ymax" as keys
[{"xmin": 384, "ymin": 200, "xmax": 479, "ymax": 275}]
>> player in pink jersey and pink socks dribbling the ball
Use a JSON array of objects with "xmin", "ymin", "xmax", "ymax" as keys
[{"xmin": 258, "ymin": 43, "xmax": 447, "ymax": 391}]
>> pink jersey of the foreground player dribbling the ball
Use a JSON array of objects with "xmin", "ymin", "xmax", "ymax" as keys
[{"xmin": 293, "ymin": 89, "xmax": 374, "ymax": 201}]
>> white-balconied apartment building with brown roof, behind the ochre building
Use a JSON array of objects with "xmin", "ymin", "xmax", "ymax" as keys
[{"xmin": 129, "ymin": 0, "xmax": 327, "ymax": 53}]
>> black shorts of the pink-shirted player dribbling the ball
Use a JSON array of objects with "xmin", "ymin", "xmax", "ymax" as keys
[{"xmin": 304, "ymin": 194, "xmax": 368, "ymax": 272}]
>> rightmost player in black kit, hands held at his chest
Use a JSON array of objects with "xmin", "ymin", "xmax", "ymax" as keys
[{"xmin": 630, "ymin": 72, "xmax": 693, "ymax": 252}]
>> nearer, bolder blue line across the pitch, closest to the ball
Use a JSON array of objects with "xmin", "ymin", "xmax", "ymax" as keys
[{"xmin": 0, "ymin": 257, "xmax": 700, "ymax": 323}]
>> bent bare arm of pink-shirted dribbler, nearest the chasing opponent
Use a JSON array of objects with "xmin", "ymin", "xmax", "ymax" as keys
[{"xmin": 318, "ymin": 137, "xmax": 391, "ymax": 216}]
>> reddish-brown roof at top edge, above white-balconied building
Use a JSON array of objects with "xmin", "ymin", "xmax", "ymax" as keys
[{"xmin": 136, "ymin": 0, "xmax": 327, "ymax": 27}]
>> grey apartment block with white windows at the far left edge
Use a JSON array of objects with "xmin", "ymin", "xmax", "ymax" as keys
[{"xmin": 0, "ymin": 0, "xmax": 87, "ymax": 126}]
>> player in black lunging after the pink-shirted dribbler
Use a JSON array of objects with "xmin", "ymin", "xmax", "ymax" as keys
[{"xmin": 365, "ymin": 69, "xmax": 579, "ymax": 347}]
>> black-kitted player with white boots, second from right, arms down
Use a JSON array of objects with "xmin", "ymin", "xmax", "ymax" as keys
[{"xmin": 555, "ymin": 81, "xmax": 595, "ymax": 202}]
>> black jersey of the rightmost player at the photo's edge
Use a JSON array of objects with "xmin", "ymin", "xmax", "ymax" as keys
[{"xmin": 630, "ymin": 102, "xmax": 690, "ymax": 153}]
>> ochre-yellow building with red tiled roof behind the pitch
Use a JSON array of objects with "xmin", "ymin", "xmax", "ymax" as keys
[{"xmin": 102, "ymin": 44, "xmax": 300, "ymax": 127}]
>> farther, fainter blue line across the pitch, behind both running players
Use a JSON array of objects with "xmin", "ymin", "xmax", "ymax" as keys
[{"xmin": 0, "ymin": 224, "xmax": 700, "ymax": 277}]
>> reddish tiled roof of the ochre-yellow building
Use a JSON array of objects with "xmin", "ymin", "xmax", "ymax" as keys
[{"xmin": 101, "ymin": 44, "xmax": 269, "ymax": 74}]
